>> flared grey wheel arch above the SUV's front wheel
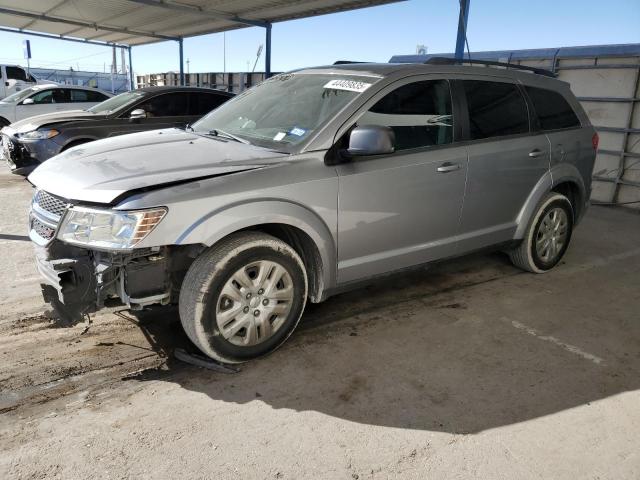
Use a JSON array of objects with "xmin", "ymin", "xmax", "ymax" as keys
[{"xmin": 175, "ymin": 199, "xmax": 336, "ymax": 288}]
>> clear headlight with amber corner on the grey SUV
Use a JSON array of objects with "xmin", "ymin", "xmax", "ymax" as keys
[{"xmin": 58, "ymin": 207, "xmax": 167, "ymax": 250}]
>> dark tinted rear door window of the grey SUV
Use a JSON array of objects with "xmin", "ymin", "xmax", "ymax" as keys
[{"xmin": 462, "ymin": 80, "xmax": 529, "ymax": 140}]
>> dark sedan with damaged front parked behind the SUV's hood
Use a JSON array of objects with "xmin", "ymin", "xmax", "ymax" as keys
[{"xmin": 1, "ymin": 87, "xmax": 233, "ymax": 175}]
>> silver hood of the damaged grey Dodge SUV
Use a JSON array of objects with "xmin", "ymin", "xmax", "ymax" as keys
[{"xmin": 29, "ymin": 129, "xmax": 283, "ymax": 203}]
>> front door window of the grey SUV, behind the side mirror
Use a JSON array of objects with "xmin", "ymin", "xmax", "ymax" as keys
[{"xmin": 358, "ymin": 80, "xmax": 453, "ymax": 150}]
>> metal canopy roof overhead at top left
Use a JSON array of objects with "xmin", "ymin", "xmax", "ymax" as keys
[{"xmin": 0, "ymin": 0, "xmax": 402, "ymax": 46}]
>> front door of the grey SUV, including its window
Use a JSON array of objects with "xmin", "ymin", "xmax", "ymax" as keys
[{"xmin": 336, "ymin": 77, "xmax": 467, "ymax": 283}]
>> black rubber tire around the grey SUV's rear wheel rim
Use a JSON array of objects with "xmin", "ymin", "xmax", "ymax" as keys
[{"xmin": 508, "ymin": 192, "xmax": 573, "ymax": 273}]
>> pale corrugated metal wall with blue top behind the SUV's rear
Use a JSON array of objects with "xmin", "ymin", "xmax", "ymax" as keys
[{"xmin": 391, "ymin": 44, "xmax": 640, "ymax": 209}]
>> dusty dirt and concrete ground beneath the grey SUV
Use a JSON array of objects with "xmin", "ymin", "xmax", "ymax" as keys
[{"xmin": 0, "ymin": 168, "xmax": 640, "ymax": 480}]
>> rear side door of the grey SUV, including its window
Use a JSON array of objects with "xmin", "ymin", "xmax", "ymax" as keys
[{"xmin": 460, "ymin": 77, "xmax": 549, "ymax": 252}]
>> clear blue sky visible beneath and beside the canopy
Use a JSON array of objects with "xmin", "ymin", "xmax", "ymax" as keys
[{"xmin": 0, "ymin": 0, "xmax": 640, "ymax": 74}]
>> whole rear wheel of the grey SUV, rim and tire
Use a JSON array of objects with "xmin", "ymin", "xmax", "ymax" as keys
[{"xmin": 509, "ymin": 192, "xmax": 573, "ymax": 273}]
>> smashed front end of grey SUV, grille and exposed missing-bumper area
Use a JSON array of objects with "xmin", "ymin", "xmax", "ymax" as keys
[{"xmin": 29, "ymin": 190, "xmax": 197, "ymax": 323}]
